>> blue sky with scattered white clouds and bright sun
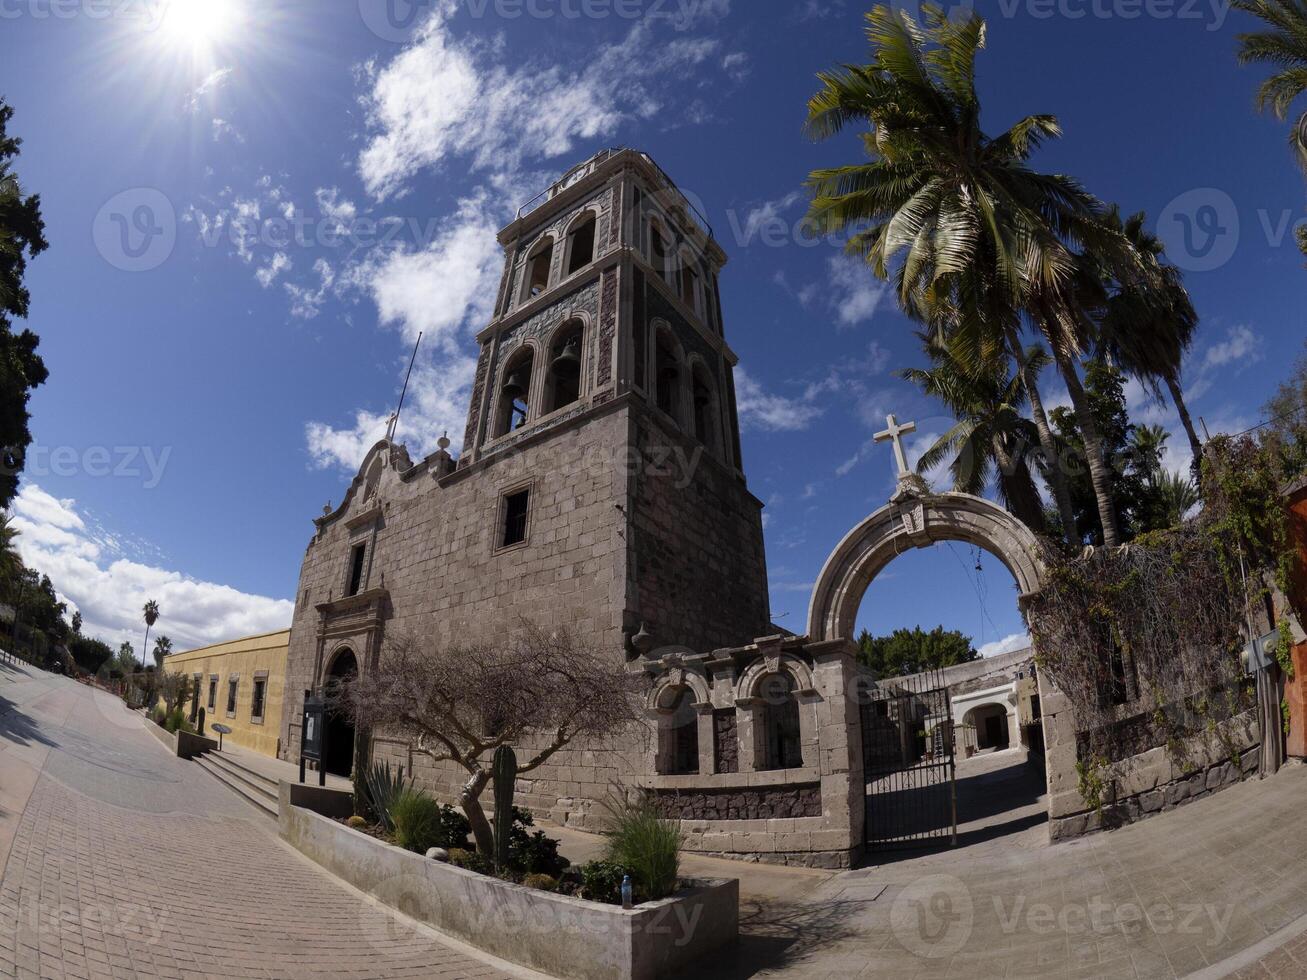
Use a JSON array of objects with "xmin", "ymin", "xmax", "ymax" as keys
[{"xmin": 0, "ymin": 0, "xmax": 1307, "ymax": 661}]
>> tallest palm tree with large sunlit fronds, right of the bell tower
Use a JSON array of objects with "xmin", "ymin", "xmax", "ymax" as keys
[{"xmin": 808, "ymin": 4, "xmax": 1128, "ymax": 544}]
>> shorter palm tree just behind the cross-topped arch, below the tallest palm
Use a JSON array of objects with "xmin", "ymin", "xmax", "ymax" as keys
[{"xmin": 899, "ymin": 333, "xmax": 1048, "ymax": 533}]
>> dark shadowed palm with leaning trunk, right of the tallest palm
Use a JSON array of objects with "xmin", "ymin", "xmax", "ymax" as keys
[{"xmin": 1095, "ymin": 205, "xmax": 1202, "ymax": 472}]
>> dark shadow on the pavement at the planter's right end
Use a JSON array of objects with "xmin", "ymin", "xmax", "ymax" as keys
[{"xmin": 678, "ymin": 900, "xmax": 867, "ymax": 980}]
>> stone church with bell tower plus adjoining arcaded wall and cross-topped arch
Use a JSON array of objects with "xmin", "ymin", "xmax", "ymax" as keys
[{"xmin": 280, "ymin": 149, "xmax": 1256, "ymax": 868}]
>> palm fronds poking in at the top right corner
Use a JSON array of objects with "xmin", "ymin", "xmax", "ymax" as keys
[{"xmin": 1234, "ymin": 0, "xmax": 1307, "ymax": 184}]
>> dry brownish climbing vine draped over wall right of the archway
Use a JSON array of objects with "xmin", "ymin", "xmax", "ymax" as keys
[{"xmin": 1026, "ymin": 436, "xmax": 1294, "ymax": 808}]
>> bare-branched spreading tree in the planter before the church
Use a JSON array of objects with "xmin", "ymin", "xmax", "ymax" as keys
[{"xmin": 337, "ymin": 621, "xmax": 640, "ymax": 853}]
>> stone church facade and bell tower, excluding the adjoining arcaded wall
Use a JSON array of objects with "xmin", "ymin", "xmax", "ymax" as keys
[{"xmin": 280, "ymin": 150, "xmax": 770, "ymax": 826}]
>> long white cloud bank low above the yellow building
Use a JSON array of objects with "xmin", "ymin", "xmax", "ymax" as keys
[{"xmin": 12, "ymin": 483, "xmax": 294, "ymax": 649}]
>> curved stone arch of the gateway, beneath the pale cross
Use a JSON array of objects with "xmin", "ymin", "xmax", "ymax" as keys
[{"xmin": 808, "ymin": 490, "xmax": 1044, "ymax": 642}]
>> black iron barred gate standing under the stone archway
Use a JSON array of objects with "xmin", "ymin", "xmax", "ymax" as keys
[{"xmin": 861, "ymin": 670, "xmax": 958, "ymax": 847}]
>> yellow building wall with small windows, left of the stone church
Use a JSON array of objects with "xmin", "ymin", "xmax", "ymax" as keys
[{"xmin": 163, "ymin": 630, "xmax": 290, "ymax": 757}]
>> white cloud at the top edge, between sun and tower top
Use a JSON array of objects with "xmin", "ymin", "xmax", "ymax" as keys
[{"xmin": 358, "ymin": 0, "xmax": 729, "ymax": 199}]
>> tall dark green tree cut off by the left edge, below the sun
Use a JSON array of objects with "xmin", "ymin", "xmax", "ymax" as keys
[{"xmin": 0, "ymin": 98, "xmax": 48, "ymax": 508}]
